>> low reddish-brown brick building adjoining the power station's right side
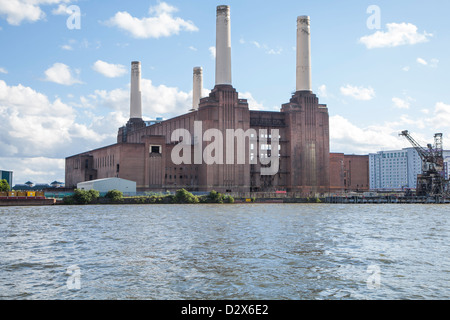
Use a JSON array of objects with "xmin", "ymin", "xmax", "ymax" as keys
[{"xmin": 330, "ymin": 153, "xmax": 370, "ymax": 192}]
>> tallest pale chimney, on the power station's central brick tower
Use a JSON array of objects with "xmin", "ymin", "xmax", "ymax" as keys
[{"xmin": 216, "ymin": 6, "xmax": 231, "ymax": 85}]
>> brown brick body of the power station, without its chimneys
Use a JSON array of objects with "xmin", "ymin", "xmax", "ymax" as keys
[{"xmin": 66, "ymin": 85, "xmax": 330, "ymax": 196}]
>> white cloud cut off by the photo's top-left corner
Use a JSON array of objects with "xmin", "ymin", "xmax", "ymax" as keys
[{"xmin": 0, "ymin": 0, "xmax": 70, "ymax": 26}]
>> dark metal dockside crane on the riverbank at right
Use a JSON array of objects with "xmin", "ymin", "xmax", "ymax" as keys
[{"xmin": 400, "ymin": 130, "xmax": 449, "ymax": 197}]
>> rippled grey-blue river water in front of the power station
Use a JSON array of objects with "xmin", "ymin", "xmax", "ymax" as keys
[{"xmin": 0, "ymin": 204, "xmax": 450, "ymax": 300}]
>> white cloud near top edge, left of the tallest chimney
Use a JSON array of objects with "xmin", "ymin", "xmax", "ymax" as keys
[{"xmin": 105, "ymin": 2, "xmax": 198, "ymax": 39}]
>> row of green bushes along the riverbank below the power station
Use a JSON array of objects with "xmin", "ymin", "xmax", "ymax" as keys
[{"xmin": 62, "ymin": 189, "xmax": 234, "ymax": 205}]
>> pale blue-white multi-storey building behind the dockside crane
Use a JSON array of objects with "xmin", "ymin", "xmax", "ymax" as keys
[{"xmin": 369, "ymin": 148, "xmax": 450, "ymax": 191}]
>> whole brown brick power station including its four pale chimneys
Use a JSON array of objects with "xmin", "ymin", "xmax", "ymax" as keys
[{"xmin": 66, "ymin": 6, "xmax": 330, "ymax": 195}]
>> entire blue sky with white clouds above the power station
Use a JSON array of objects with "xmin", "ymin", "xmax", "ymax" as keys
[{"xmin": 0, "ymin": 0, "xmax": 450, "ymax": 183}]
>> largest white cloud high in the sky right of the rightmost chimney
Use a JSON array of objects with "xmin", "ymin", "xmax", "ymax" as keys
[{"xmin": 359, "ymin": 22, "xmax": 433, "ymax": 49}]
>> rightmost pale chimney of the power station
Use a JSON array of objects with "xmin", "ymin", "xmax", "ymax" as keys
[{"xmin": 297, "ymin": 16, "xmax": 312, "ymax": 91}]
